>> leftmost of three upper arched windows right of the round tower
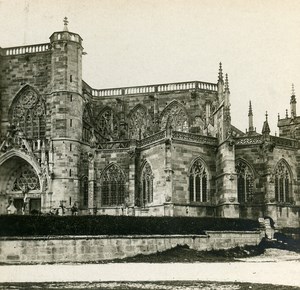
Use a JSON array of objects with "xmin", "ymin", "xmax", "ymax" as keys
[{"xmin": 97, "ymin": 108, "xmax": 119, "ymax": 141}]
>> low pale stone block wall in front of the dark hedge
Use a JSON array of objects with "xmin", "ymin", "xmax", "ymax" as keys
[{"xmin": 0, "ymin": 231, "xmax": 261, "ymax": 264}]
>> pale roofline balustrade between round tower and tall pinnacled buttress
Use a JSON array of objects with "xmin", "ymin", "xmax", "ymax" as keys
[{"xmin": 92, "ymin": 81, "xmax": 218, "ymax": 97}]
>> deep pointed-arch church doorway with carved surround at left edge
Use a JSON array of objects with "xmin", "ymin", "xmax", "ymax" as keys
[{"xmin": 0, "ymin": 155, "xmax": 42, "ymax": 214}]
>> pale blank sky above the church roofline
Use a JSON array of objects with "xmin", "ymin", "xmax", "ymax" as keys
[{"xmin": 0, "ymin": 0, "xmax": 300, "ymax": 135}]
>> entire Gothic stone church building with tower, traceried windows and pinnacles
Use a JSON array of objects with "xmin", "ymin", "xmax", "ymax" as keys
[{"xmin": 0, "ymin": 22, "xmax": 300, "ymax": 227}]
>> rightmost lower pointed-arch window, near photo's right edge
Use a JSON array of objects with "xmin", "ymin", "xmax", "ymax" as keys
[{"xmin": 274, "ymin": 160, "xmax": 291, "ymax": 202}]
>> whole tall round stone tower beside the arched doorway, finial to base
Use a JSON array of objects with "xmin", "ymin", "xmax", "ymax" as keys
[{"xmin": 49, "ymin": 17, "xmax": 83, "ymax": 207}]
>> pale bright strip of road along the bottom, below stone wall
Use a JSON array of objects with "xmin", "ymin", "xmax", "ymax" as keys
[{"xmin": 0, "ymin": 261, "xmax": 300, "ymax": 287}]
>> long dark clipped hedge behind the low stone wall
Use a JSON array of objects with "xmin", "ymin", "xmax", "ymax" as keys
[{"xmin": 0, "ymin": 215, "xmax": 259, "ymax": 236}]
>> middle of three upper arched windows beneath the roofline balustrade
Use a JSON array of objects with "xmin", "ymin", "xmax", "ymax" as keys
[{"xmin": 129, "ymin": 105, "xmax": 147, "ymax": 140}]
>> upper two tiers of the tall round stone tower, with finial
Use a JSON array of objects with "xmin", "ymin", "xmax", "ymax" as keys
[{"xmin": 50, "ymin": 17, "xmax": 83, "ymax": 140}]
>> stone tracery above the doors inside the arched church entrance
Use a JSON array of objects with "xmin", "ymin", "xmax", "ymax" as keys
[{"xmin": 13, "ymin": 165, "xmax": 40, "ymax": 192}]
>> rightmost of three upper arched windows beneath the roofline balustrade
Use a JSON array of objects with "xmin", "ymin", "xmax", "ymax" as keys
[{"xmin": 161, "ymin": 101, "xmax": 189, "ymax": 132}]
